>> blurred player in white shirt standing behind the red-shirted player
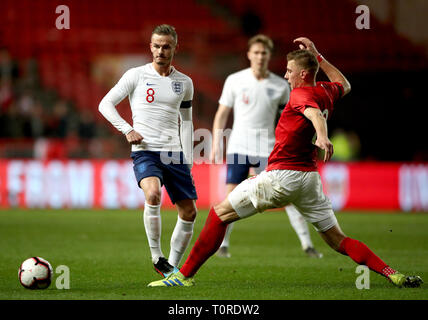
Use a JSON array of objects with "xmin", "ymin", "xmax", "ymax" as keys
[{"xmin": 211, "ymin": 34, "xmax": 322, "ymax": 258}]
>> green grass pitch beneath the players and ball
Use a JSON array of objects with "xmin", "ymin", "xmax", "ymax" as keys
[{"xmin": 0, "ymin": 209, "xmax": 428, "ymax": 300}]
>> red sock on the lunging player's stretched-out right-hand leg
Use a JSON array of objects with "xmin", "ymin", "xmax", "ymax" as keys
[{"xmin": 339, "ymin": 237, "xmax": 396, "ymax": 277}]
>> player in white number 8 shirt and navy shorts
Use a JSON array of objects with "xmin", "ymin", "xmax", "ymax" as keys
[{"xmin": 99, "ymin": 25, "xmax": 197, "ymax": 277}]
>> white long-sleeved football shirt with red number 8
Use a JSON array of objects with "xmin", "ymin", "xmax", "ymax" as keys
[{"xmin": 99, "ymin": 63, "xmax": 193, "ymax": 151}]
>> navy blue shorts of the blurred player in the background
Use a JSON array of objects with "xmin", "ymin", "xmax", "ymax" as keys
[{"xmin": 226, "ymin": 153, "xmax": 268, "ymax": 184}]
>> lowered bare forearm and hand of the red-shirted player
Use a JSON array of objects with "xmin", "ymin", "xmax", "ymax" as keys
[{"xmin": 303, "ymin": 107, "xmax": 334, "ymax": 162}]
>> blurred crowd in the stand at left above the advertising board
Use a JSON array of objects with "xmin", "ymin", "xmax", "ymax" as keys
[{"xmin": 0, "ymin": 48, "xmax": 127, "ymax": 158}]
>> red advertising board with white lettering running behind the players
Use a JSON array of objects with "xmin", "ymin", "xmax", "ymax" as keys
[{"xmin": 0, "ymin": 160, "xmax": 428, "ymax": 211}]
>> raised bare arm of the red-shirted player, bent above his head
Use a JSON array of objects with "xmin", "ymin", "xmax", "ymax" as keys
[{"xmin": 293, "ymin": 37, "xmax": 351, "ymax": 95}]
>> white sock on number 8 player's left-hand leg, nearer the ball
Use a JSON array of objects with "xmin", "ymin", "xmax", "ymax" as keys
[{"xmin": 143, "ymin": 202, "xmax": 164, "ymax": 263}]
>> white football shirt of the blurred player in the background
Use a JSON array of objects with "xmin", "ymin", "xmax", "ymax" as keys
[{"xmin": 219, "ymin": 68, "xmax": 290, "ymax": 158}]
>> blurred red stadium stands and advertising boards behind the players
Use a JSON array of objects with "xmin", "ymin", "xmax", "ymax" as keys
[{"xmin": 0, "ymin": 0, "xmax": 428, "ymax": 212}]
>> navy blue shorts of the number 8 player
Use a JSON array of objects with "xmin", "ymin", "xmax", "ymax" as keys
[{"xmin": 131, "ymin": 151, "xmax": 198, "ymax": 204}]
